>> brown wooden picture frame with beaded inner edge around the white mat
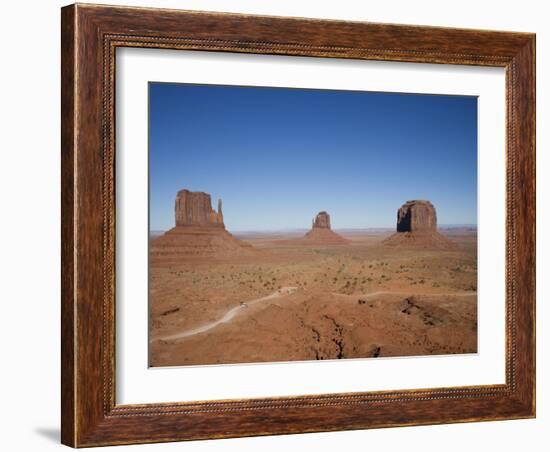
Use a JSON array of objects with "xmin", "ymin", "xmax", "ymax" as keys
[{"xmin": 61, "ymin": 4, "xmax": 535, "ymax": 447}]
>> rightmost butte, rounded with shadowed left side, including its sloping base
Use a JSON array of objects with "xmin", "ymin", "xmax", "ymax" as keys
[{"xmin": 383, "ymin": 200, "xmax": 454, "ymax": 249}]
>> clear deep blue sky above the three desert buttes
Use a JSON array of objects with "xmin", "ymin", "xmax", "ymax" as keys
[{"xmin": 149, "ymin": 83, "xmax": 477, "ymax": 231}]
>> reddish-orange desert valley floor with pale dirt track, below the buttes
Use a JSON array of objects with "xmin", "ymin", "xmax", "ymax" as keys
[{"xmin": 149, "ymin": 229, "xmax": 477, "ymax": 366}]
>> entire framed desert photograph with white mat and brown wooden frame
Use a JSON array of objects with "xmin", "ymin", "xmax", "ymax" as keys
[{"xmin": 61, "ymin": 4, "xmax": 535, "ymax": 447}]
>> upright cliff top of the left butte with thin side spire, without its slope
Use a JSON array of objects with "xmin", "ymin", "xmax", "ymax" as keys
[{"xmin": 175, "ymin": 190, "xmax": 225, "ymax": 229}]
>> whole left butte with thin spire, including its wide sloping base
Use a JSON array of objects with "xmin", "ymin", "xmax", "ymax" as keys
[{"xmin": 149, "ymin": 190, "xmax": 252, "ymax": 263}]
